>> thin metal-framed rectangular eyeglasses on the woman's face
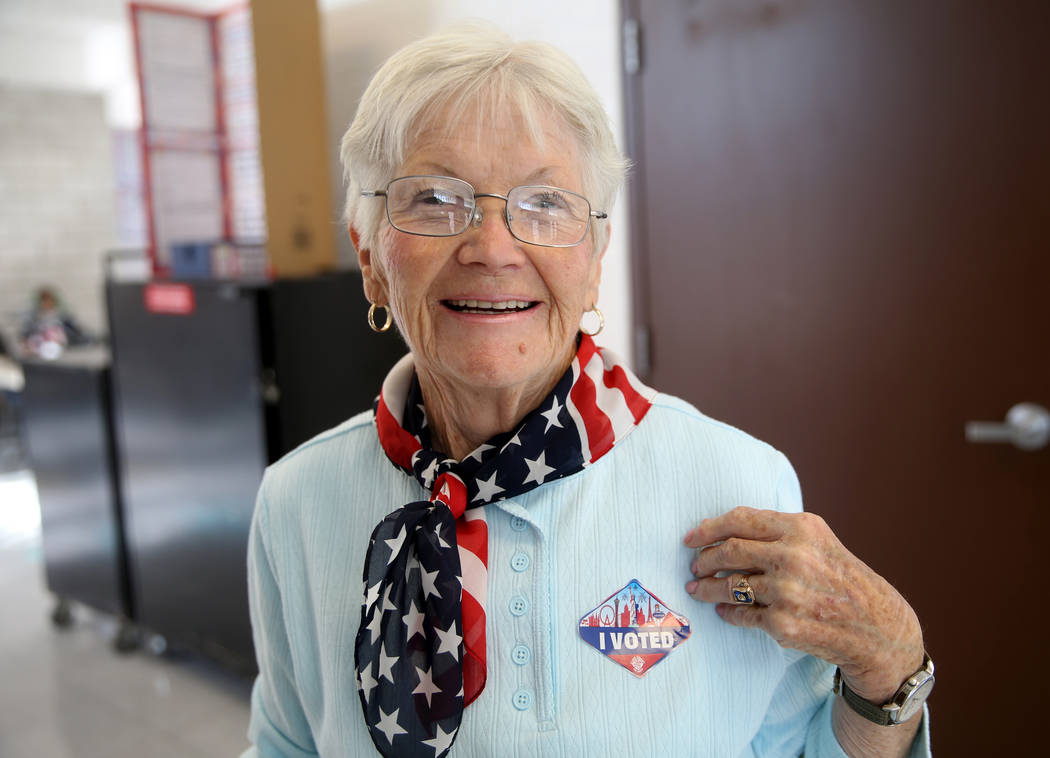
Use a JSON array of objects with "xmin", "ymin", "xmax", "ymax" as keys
[{"xmin": 361, "ymin": 176, "xmax": 608, "ymax": 248}]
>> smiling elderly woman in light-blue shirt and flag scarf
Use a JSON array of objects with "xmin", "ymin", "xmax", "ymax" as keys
[{"xmin": 249, "ymin": 27, "xmax": 932, "ymax": 758}]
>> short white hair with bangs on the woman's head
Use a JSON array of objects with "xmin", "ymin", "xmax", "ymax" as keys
[{"xmin": 340, "ymin": 23, "xmax": 628, "ymax": 251}]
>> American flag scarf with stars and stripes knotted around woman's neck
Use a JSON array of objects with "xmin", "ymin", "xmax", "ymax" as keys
[{"xmin": 355, "ymin": 335, "xmax": 656, "ymax": 758}]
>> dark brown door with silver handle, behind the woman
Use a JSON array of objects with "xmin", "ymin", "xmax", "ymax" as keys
[{"xmin": 624, "ymin": 0, "xmax": 1050, "ymax": 756}]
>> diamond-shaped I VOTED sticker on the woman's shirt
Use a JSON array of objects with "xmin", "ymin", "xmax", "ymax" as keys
[{"xmin": 580, "ymin": 580, "xmax": 691, "ymax": 677}]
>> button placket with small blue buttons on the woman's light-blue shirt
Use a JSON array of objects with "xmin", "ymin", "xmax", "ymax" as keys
[{"xmin": 488, "ymin": 501, "xmax": 557, "ymax": 732}]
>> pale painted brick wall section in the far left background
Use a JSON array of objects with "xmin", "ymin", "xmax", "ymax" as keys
[{"xmin": 0, "ymin": 84, "xmax": 116, "ymax": 342}]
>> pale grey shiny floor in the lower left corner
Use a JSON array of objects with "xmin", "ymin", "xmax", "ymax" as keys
[{"xmin": 0, "ymin": 471, "xmax": 250, "ymax": 758}]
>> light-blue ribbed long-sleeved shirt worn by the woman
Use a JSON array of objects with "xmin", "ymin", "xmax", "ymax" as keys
[{"xmin": 238, "ymin": 395, "xmax": 929, "ymax": 758}]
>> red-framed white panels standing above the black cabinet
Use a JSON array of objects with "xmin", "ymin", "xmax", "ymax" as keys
[{"xmin": 130, "ymin": 3, "xmax": 266, "ymax": 275}]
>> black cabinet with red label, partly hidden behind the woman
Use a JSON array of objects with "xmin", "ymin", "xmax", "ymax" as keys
[{"xmin": 107, "ymin": 272, "xmax": 405, "ymax": 670}]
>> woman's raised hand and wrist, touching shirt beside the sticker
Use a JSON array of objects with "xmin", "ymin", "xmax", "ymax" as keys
[{"xmin": 685, "ymin": 507, "xmax": 923, "ymax": 703}]
